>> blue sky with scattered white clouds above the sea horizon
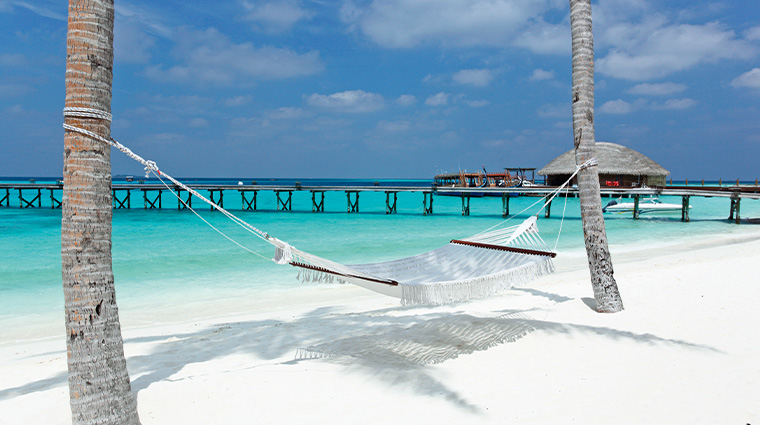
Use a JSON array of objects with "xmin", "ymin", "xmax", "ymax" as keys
[{"xmin": 0, "ymin": 0, "xmax": 760, "ymax": 180}]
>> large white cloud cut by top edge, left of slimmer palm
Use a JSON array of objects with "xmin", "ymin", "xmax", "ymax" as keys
[{"xmin": 341, "ymin": 0, "xmax": 570, "ymax": 51}]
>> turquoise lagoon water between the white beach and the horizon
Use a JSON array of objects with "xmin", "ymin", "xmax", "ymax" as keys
[{"xmin": 0, "ymin": 180, "xmax": 760, "ymax": 332}]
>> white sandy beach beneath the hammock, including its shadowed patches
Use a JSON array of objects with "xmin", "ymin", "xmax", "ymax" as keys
[{"xmin": 0, "ymin": 226, "xmax": 760, "ymax": 425}]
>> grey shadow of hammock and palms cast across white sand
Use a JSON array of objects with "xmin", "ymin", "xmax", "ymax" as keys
[{"xmin": 127, "ymin": 307, "xmax": 717, "ymax": 413}]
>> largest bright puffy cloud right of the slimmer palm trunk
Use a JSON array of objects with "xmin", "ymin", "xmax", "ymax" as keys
[{"xmin": 596, "ymin": 21, "xmax": 757, "ymax": 81}]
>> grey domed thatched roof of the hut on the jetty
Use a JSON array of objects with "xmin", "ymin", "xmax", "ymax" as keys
[{"xmin": 537, "ymin": 142, "xmax": 670, "ymax": 176}]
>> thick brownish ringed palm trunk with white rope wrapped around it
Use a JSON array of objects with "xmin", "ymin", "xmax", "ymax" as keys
[{"xmin": 61, "ymin": 0, "xmax": 140, "ymax": 424}]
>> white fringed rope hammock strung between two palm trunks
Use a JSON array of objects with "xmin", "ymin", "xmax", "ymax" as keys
[{"xmin": 63, "ymin": 108, "xmax": 596, "ymax": 304}]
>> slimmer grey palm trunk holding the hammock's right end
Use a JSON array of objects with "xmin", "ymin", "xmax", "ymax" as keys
[{"xmin": 570, "ymin": 0, "xmax": 623, "ymax": 313}]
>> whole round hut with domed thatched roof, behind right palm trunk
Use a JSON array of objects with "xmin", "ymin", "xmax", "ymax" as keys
[{"xmin": 538, "ymin": 142, "xmax": 670, "ymax": 187}]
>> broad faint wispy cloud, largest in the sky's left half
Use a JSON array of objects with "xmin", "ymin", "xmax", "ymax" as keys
[{"xmin": 146, "ymin": 28, "xmax": 324, "ymax": 85}]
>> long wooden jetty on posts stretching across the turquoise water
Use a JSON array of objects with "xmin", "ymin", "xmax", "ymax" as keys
[{"xmin": 0, "ymin": 183, "xmax": 760, "ymax": 223}]
